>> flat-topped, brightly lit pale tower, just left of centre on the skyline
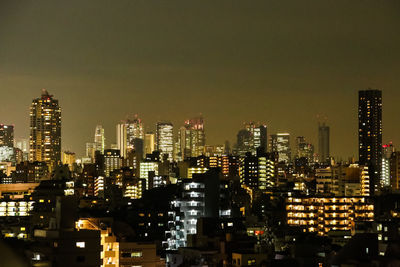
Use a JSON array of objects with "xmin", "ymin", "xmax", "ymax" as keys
[{"xmin": 156, "ymin": 122, "xmax": 174, "ymax": 161}]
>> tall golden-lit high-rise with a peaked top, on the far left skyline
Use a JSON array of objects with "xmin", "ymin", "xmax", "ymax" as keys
[{"xmin": 29, "ymin": 89, "xmax": 61, "ymax": 171}]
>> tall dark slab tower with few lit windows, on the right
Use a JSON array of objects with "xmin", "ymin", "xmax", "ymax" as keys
[{"xmin": 358, "ymin": 89, "xmax": 382, "ymax": 195}]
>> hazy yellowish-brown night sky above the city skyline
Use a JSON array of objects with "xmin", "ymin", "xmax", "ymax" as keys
[{"xmin": 0, "ymin": 0, "xmax": 400, "ymax": 159}]
